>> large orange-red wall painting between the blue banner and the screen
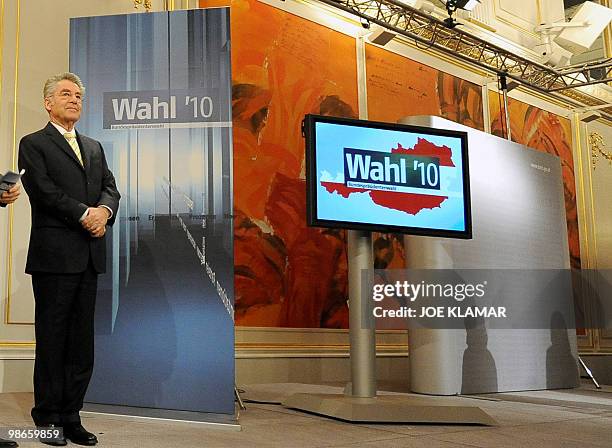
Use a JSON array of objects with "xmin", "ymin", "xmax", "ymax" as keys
[{"xmin": 224, "ymin": 0, "xmax": 358, "ymax": 328}]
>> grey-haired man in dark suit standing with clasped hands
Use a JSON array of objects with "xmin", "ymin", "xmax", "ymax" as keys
[{"xmin": 19, "ymin": 73, "xmax": 120, "ymax": 446}]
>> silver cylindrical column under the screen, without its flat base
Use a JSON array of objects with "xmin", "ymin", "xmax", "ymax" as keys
[{"xmin": 348, "ymin": 230, "xmax": 376, "ymax": 398}]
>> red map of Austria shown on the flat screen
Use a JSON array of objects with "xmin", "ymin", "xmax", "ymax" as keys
[{"xmin": 321, "ymin": 138, "xmax": 455, "ymax": 215}]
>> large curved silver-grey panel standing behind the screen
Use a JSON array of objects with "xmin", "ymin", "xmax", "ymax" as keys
[{"xmin": 401, "ymin": 116, "xmax": 578, "ymax": 395}]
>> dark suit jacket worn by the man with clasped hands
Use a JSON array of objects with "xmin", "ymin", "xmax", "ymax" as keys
[{"xmin": 19, "ymin": 123, "xmax": 120, "ymax": 274}]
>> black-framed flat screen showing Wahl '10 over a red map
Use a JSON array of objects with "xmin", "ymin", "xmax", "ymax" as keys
[{"xmin": 303, "ymin": 115, "xmax": 472, "ymax": 239}]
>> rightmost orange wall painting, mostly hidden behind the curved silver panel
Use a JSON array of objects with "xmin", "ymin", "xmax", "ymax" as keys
[{"xmin": 489, "ymin": 92, "xmax": 580, "ymax": 269}]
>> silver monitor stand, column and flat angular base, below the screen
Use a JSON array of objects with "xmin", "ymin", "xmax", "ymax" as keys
[{"xmin": 283, "ymin": 230, "xmax": 497, "ymax": 425}]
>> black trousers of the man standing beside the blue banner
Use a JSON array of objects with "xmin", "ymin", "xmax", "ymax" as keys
[{"xmin": 32, "ymin": 262, "xmax": 98, "ymax": 426}]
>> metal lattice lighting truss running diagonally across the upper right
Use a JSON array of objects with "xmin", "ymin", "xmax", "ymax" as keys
[{"xmin": 318, "ymin": 0, "xmax": 612, "ymax": 98}]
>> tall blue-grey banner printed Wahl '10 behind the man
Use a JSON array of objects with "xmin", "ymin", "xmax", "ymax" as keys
[{"xmin": 70, "ymin": 8, "xmax": 234, "ymax": 416}]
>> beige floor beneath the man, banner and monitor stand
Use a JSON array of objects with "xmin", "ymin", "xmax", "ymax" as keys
[{"xmin": 0, "ymin": 383, "xmax": 612, "ymax": 448}]
